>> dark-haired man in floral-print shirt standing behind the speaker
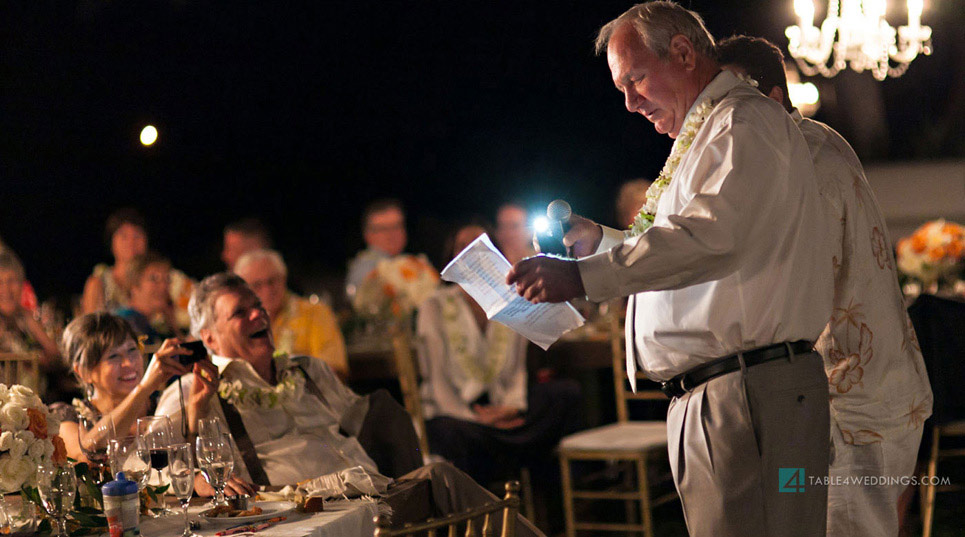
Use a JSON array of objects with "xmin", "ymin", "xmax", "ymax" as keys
[{"xmin": 718, "ymin": 36, "xmax": 932, "ymax": 537}]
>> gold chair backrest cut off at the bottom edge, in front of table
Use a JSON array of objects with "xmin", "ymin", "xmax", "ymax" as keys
[{"xmin": 375, "ymin": 481, "xmax": 519, "ymax": 537}]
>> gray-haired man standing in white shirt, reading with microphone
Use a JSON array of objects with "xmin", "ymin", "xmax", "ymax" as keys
[{"xmin": 507, "ymin": 2, "xmax": 834, "ymax": 537}]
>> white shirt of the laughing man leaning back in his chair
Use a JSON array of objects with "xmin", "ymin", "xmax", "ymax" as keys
[{"xmin": 155, "ymin": 356, "xmax": 378, "ymax": 485}]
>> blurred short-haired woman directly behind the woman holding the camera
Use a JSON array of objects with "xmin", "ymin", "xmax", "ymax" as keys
[{"xmin": 116, "ymin": 251, "xmax": 181, "ymax": 345}]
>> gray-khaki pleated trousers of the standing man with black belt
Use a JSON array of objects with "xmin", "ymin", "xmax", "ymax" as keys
[{"xmin": 667, "ymin": 352, "xmax": 830, "ymax": 537}]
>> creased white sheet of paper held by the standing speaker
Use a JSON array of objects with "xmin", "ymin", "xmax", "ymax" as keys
[{"xmin": 442, "ymin": 233, "xmax": 584, "ymax": 349}]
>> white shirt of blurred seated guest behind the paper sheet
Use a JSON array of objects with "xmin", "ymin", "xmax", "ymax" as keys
[{"xmin": 417, "ymin": 285, "xmax": 527, "ymax": 421}]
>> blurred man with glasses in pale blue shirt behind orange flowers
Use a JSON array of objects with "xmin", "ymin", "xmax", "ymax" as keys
[{"xmin": 345, "ymin": 199, "xmax": 408, "ymax": 297}]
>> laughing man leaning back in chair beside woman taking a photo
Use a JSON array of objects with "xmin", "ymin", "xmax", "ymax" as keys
[{"xmin": 156, "ymin": 273, "xmax": 542, "ymax": 535}]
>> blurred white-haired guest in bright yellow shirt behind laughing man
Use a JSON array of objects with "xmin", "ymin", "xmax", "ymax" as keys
[{"xmin": 235, "ymin": 250, "xmax": 348, "ymax": 379}]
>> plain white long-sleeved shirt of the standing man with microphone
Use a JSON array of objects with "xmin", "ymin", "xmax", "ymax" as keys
[{"xmin": 578, "ymin": 71, "xmax": 836, "ymax": 380}]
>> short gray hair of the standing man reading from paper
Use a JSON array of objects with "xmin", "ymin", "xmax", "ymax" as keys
[{"xmin": 595, "ymin": 1, "xmax": 717, "ymax": 60}]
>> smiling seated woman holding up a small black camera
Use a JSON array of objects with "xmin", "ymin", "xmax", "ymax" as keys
[{"xmin": 51, "ymin": 312, "xmax": 253, "ymax": 495}]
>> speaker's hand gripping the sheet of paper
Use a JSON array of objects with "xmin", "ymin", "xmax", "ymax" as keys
[{"xmin": 506, "ymin": 255, "xmax": 586, "ymax": 304}]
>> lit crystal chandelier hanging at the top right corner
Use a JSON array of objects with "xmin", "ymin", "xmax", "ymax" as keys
[{"xmin": 784, "ymin": 0, "xmax": 931, "ymax": 80}]
